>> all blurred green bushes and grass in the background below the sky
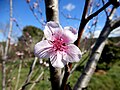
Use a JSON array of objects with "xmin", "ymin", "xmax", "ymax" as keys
[{"xmin": 0, "ymin": 26, "xmax": 120, "ymax": 90}]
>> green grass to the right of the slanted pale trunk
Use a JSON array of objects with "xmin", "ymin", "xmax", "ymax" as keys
[{"xmin": 88, "ymin": 61, "xmax": 120, "ymax": 90}]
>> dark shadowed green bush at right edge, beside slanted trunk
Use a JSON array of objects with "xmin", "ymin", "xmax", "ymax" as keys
[{"xmin": 97, "ymin": 39, "xmax": 120, "ymax": 70}]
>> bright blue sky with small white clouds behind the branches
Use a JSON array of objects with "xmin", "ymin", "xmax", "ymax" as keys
[{"xmin": 0, "ymin": 0, "xmax": 120, "ymax": 41}]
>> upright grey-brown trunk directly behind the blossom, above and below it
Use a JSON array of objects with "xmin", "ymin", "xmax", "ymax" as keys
[{"xmin": 45, "ymin": 0, "xmax": 61, "ymax": 90}]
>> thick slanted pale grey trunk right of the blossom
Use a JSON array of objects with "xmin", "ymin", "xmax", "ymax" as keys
[{"xmin": 74, "ymin": 18, "xmax": 120, "ymax": 90}]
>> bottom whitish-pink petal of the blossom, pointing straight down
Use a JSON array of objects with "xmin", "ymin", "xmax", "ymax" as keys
[{"xmin": 50, "ymin": 51, "xmax": 67, "ymax": 68}]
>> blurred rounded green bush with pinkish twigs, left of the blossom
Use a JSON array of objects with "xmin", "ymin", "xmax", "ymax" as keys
[{"xmin": 8, "ymin": 26, "xmax": 43, "ymax": 59}]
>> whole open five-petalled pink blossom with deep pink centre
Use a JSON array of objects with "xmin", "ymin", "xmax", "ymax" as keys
[{"xmin": 34, "ymin": 21, "xmax": 81, "ymax": 68}]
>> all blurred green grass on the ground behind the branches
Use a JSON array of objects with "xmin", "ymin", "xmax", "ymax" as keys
[{"xmin": 0, "ymin": 59, "xmax": 120, "ymax": 90}]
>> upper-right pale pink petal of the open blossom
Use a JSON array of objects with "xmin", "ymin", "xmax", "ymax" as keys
[{"xmin": 62, "ymin": 27, "xmax": 78, "ymax": 43}]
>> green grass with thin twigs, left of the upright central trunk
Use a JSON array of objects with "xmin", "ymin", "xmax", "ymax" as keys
[{"xmin": 0, "ymin": 58, "xmax": 50, "ymax": 90}]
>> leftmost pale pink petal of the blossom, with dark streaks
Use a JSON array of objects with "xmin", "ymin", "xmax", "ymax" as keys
[{"xmin": 34, "ymin": 40, "xmax": 53, "ymax": 58}]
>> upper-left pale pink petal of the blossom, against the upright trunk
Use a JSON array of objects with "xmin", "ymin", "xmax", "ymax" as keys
[{"xmin": 44, "ymin": 21, "xmax": 63, "ymax": 40}]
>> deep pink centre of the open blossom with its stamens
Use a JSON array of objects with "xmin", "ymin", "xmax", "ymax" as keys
[{"xmin": 53, "ymin": 38, "xmax": 66, "ymax": 51}]
